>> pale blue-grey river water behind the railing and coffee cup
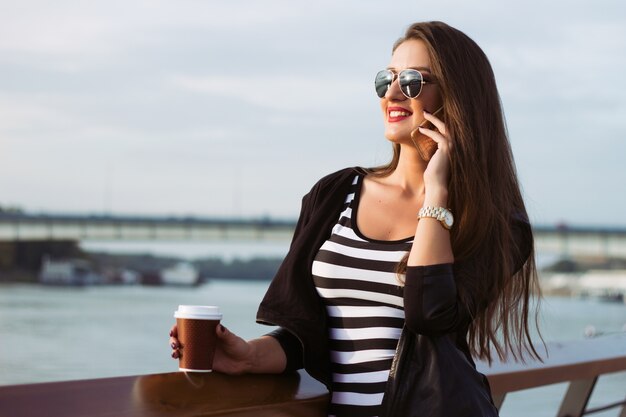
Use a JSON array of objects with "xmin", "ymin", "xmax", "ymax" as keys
[{"xmin": 0, "ymin": 280, "xmax": 626, "ymax": 417}]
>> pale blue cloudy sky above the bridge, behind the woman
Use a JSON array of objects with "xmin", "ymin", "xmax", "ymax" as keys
[{"xmin": 0, "ymin": 0, "xmax": 626, "ymax": 226}]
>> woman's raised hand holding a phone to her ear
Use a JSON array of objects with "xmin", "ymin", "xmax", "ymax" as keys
[{"xmin": 419, "ymin": 111, "xmax": 452, "ymax": 193}]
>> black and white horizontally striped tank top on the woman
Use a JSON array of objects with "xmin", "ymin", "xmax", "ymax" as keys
[{"xmin": 312, "ymin": 175, "xmax": 413, "ymax": 417}]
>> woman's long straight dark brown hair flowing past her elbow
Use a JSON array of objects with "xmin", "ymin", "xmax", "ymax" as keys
[{"xmin": 368, "ymin": 22, "xmax": 541, "ymax": 363}]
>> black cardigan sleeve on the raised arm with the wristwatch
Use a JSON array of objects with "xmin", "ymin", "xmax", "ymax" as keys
[{"xmin": 404, "ymin": 214, "xmax": 533, "ymax": 335}]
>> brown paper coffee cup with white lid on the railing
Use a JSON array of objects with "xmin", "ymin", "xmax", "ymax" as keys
[{"xmin": 174, "ymin": 305, "xmax": 222, "ymax": 372}]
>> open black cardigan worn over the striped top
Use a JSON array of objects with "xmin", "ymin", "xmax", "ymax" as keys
[{"xmin": 257, "ymin": 168, "xmax": 532, "ymax": 416}]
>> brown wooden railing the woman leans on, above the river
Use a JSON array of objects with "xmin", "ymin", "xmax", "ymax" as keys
[{"xmin": 0, "ymin": 334, "xmax": 626, "ymax": 417}]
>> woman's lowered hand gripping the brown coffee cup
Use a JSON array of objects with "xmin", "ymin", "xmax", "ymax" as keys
[{"xmin": 170, "ymin": 324, "xmax": 254, "ymax": 375}]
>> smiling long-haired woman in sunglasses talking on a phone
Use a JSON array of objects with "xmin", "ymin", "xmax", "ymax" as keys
[{"xmin": 170, "ymin": 22, "xmax": 539, "ymax": 417}]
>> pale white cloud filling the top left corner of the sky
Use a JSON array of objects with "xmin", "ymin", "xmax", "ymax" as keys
[{"xmin": 0, "ymin": 0, "xmax": 301, "ymax": 73}]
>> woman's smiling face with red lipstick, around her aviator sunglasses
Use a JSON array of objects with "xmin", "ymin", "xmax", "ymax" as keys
[{"xmin": 380, "ymin": 39, "xmax": 442, "ymax": 144}]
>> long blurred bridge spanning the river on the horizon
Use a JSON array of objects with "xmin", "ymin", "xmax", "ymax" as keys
[{"xmin": 0, "ymin": 212, "xmax": 626, "ymax": 257}]
